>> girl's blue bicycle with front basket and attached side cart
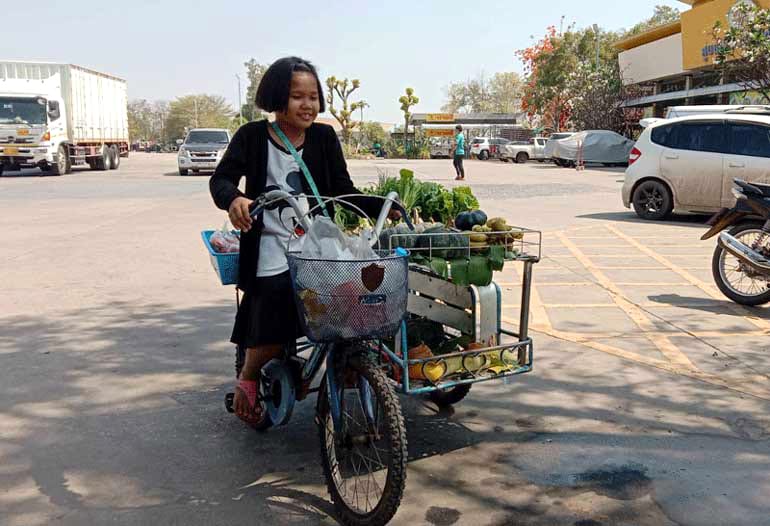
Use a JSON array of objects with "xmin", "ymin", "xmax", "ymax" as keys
[{"xmin": 203, "ymin": 191, "xmax": 540, "ymax": 526}]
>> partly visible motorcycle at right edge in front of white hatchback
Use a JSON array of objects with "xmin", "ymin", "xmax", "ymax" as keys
[{"xmin": 701, "ymin": 179, "xmax": 770, "ymax": 306}]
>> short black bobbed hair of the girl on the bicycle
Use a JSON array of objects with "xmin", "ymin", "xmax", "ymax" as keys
[{"xmin": 254, "ymin": 57, "xmax": 326, "ymax": 113}]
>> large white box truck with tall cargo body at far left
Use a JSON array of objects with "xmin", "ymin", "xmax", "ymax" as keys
[{"xmin": 0, "ymin": 61, "xmax": 129, "ymax": 175}]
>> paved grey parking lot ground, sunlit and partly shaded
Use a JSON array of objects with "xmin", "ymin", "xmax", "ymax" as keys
[{"xmin": 0, "ymin": 154, "xmax": 770, "ymax": 526}]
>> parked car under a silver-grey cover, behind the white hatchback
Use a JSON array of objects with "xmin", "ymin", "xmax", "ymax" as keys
[{"xmin": 551, "ymin": 130, "xmax": 634, "ymax": 166}]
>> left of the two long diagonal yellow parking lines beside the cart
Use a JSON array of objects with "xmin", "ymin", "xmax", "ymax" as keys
[{"xmin": 558, "ymin": 234, "xmax": 696, "ymax": 370}]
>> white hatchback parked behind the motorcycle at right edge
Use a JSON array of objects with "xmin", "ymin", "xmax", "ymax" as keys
[{"xmin": 622, "ymin": 109, "xmax": 770, "ymax": 219}]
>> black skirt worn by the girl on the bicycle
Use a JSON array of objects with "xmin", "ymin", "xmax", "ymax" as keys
[{"xmin": 230, "ymin": 270, "xmax": 304, "ymax": 348}]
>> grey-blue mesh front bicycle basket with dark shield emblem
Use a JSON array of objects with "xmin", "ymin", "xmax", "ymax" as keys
[{"xmin": 286, "ymin": 252, "xmax": 409, "ymax": 343}]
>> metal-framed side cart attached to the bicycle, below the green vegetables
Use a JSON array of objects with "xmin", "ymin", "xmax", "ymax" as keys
[{"xmin": 381, "ymin": 227, "xmax": 542, "ymax": 405}]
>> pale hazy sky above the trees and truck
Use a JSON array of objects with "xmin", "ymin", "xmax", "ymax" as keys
[{"xmin": 0, "ymin": 0, "xmax": 688, "ymax": 122}]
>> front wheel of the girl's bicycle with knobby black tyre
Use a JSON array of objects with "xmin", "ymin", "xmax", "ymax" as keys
[{"xmin": 317, "ymin": 354, "xmax": 407, "ymax": 526}]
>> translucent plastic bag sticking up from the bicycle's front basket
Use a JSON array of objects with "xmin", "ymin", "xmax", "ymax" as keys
[{"xmin": 302, "ymin": 217, "xmax": 378, "ymax": 261}]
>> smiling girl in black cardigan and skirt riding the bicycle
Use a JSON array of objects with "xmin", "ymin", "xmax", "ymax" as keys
[{"xmin": 209, "ymin": 57, "xmax": 398, "ymax": 427}]
